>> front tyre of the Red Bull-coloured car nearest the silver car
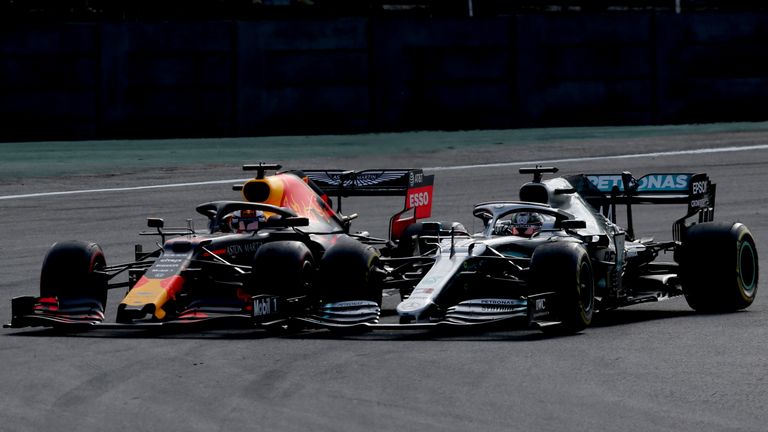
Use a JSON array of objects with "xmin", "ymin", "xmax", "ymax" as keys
[{"xmin": 248, "ymin": 241, "xmax": 315, "ymax": 297}]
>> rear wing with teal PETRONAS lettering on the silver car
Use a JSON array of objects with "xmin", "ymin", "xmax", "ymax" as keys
[{"xmin": 567, "ymin": 172, "xmax": 717, "ymax": 240}]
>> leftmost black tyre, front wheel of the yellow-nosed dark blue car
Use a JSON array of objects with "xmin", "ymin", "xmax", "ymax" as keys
[{"xmin": 40, "ymin": 240, "xmax": 107, "ymax": 310}]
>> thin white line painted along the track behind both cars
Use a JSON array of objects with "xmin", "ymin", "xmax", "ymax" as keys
[{"xmin": 0, "ymin": 144, "xmax": 768, "ymax": 200}]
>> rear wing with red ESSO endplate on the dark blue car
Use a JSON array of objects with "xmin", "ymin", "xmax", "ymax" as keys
[{"xmin": 300, "ymin": 169, "xmax": 435, "ymax": 240}]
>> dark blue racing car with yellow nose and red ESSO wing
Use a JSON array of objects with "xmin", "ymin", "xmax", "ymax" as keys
[{"xmin": 6, "ymin": 163, "xmax": 433, "ymax": 328}]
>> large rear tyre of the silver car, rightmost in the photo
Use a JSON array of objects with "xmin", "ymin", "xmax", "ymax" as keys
[{"xmin": 677, "ymin": 223, "xmax": 759, "ymax": 312}]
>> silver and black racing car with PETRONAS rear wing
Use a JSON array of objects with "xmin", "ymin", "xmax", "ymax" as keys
[{"xmin": 302, "ymin": 167, "xmax": 758, "ymax": 333}]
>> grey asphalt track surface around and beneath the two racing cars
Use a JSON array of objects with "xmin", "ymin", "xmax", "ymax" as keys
[{"xmin": 0, "ymin": 125, "xmax": 768, "ymax": 432}]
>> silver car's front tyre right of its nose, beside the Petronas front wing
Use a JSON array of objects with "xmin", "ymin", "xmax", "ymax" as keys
[{"xmin": 531, "ymin": 242, "xmax": 595, "ymax": 334}]
